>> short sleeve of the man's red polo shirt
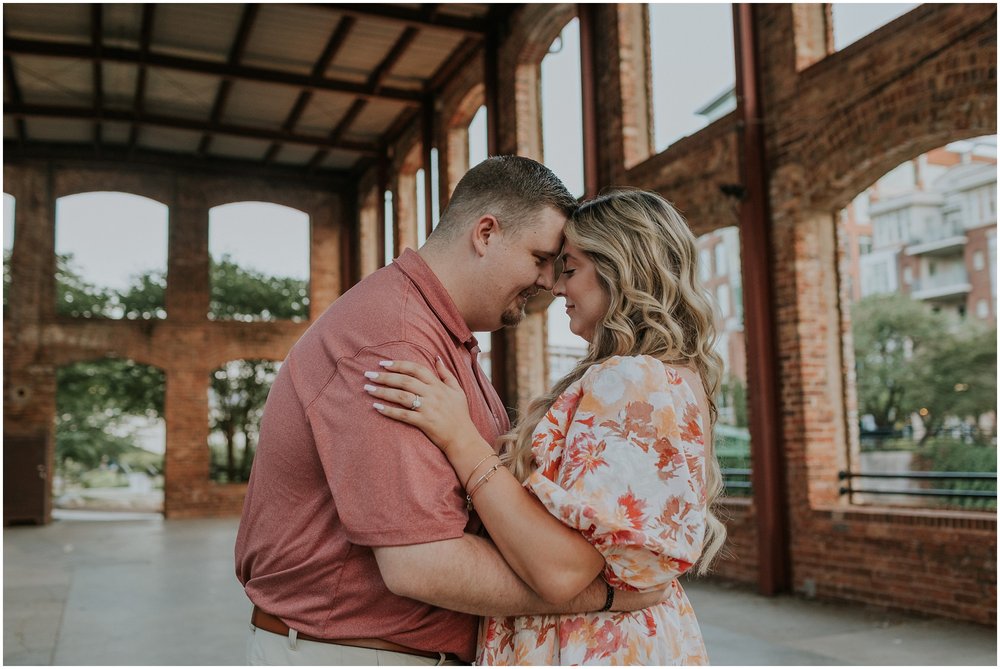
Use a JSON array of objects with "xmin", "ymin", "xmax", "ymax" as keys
[{"xmin": 308, "ymin": 342, "xmax": 469, "ymax": 546}]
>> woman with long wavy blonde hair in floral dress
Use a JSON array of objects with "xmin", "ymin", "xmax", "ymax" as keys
[{"xmin": 365, "ymin": 191, "xmax": 725, "ymax": 665}]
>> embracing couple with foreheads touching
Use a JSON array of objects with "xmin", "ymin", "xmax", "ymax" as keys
[{"xmin": 236, "ymin": 156, "xmax": 725, "ymax": 665}]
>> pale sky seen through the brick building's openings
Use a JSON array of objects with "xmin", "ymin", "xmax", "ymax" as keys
[{"xmin": 3, "ymin": 3, "xmax": 952, "ymax": 346}]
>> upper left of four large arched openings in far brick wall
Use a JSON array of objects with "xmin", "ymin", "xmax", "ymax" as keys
[{"xmin": 56, "ymin": 192, "xmax": 168, "ymax": 319}]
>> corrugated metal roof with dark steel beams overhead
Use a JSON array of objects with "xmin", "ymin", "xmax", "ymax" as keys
[{"xmin": 3, "ymin": 3, "xmax": 490, "ymax": 171}]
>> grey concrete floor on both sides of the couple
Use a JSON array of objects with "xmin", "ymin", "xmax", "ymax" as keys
[{"xmin": 3, "ymin": 512, "xmax": 997, "ymax": 666}]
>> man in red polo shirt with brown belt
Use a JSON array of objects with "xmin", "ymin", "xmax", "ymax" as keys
[{"xmin": 236, "ymin": 156, "xmax": 652, "ymax": 664}]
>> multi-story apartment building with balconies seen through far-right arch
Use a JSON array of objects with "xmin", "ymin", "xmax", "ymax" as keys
[{"xmin": 841, "ymin": 142, "xmax": 997, "ymax": 323}]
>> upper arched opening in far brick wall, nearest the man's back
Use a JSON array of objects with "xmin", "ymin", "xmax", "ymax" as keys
[{"xmin": 208, "ymin": 202, "xmax": 309, "ymax": 321}]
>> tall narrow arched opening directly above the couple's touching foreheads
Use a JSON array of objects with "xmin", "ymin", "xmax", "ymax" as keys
[{"xmin": 541, "ymin": 18, "xmax": 585, "ymax": 197}]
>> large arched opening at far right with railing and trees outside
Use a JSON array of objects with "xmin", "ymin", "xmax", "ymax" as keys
[{"xmin": 836, "ymin": 136, "xmax": 997, "ymax": 509}]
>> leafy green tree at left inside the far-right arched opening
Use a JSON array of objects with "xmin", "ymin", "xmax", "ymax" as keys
[{"xmin": 851, "ymin": 294, "xmax": 948, "ymax": 431}]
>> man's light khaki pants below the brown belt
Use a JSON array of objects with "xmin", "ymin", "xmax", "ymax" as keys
[{"xmin": 247, "ymin": 625, "xmax": 470, "ymax": 667}]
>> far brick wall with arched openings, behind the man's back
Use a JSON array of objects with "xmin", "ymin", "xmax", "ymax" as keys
[{"xmin": 4, "ymin": 162, "xmax": 350, "ymax": 518}]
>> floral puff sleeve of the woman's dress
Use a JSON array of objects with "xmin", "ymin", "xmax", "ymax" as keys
[{"xmin": 525, "ymin": 356, "xmax": 706, "ymax": 590}]
